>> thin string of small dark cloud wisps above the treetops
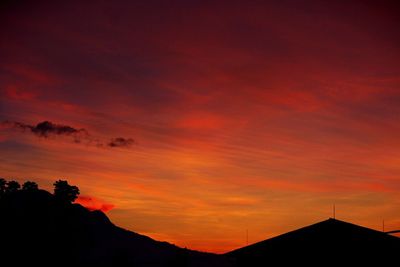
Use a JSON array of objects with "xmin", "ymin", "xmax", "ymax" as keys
[{"xmin": 1, "ymin": 121, "xmax": 135, "ymax": 148}]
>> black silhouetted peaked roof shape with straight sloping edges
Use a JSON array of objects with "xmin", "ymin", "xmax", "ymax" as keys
[{"xmin": 226, "ymin": 219, "xmax": 400, "ymax": 266}]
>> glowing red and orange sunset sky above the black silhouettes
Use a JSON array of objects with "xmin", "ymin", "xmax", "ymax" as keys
[{"xmin": 0, "ymin": 0, "xmax": 400, "ymax": 252}]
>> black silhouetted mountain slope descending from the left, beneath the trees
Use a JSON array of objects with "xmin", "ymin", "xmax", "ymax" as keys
[{"xmin": 0, "ymin": 190, "xmax": 233, "ymax": 267}]
